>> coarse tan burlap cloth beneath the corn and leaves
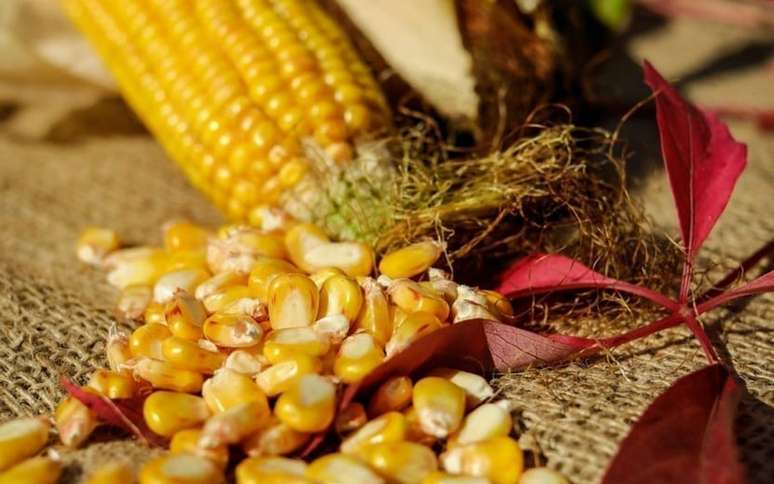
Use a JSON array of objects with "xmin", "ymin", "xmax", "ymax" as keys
[{"xmin": 0, "ymin": 14, "xmax": 774, "ymax": 483}]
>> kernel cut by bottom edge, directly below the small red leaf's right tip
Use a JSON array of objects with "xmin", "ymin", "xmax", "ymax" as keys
[{"xmin": 140, "ymin": 454, "xmax": 224, "ymax": 484}]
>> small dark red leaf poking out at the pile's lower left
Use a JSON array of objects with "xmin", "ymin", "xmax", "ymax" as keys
[{"xmin": 59, "ymin": 377, "xmax": 167, "ymax": 447}]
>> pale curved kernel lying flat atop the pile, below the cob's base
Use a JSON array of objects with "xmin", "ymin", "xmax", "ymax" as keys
[{"xmin": 302, "ymin": 242, "xmax": 374, "ymax": 277}]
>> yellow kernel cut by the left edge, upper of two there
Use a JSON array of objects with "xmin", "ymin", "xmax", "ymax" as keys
[{"xmin": 0, "ymin": 417, "xmax": 50, "ymax": 470}]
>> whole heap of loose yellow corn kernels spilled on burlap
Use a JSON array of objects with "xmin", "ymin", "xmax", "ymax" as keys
[{"xmin": 0, "ymin": 209, "xmax": 567, "ymax": 484}]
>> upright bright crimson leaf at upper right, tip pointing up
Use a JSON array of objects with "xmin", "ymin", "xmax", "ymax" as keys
[{"xmin": 644, "ymin": 61, "xmax": 747, "ymax": 261}]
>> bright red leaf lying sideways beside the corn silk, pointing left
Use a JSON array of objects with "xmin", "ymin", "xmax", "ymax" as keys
[{"xmin": 497, "ymin": 254, "xmax": 680, "ymax": 311}]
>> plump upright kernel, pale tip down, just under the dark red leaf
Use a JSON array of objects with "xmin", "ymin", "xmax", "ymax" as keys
[{"xmin": 412, "ymin": 376, "xmax": 465, "ymax": 439}]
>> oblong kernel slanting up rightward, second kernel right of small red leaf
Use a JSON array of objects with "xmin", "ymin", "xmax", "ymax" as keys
[{"xmin": 199, "ymin": 400, "xmax": 271, "ymax": 449}]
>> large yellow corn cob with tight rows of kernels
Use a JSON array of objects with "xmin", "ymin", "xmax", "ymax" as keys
[{"xmin": 63, "ymin": 0, "xmax": 389, "ymax": 221}]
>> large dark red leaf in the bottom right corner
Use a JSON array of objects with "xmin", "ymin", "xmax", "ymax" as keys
[{"xmin": 602, "ymin": 364, "xmax": 745, "ymax": 484}]
